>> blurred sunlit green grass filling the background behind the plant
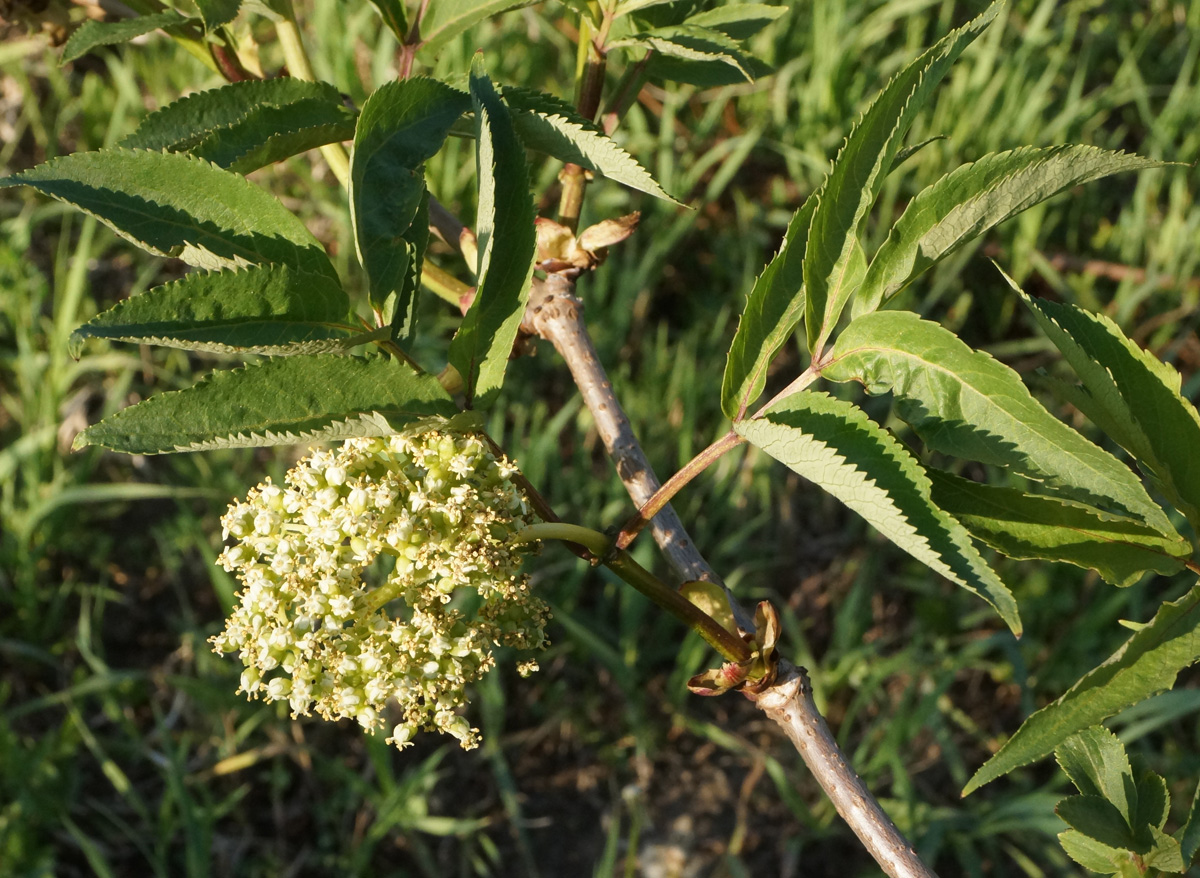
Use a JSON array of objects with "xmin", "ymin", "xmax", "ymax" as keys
[{"xmin": 0, "ymin": 0, "xmax": 1200, "ymax": 877}]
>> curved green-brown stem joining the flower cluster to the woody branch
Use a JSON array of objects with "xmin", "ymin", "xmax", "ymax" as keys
[{"xmin": 514, "ymin": 523, "xmax": 750, "ymax": 662}]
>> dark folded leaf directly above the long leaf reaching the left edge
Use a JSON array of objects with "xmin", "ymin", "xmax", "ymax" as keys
[{"xmin": 121, "ymin": 77, "xmax": 355, "ymax": 174}]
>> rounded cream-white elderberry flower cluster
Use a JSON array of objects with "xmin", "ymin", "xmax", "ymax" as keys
[{"xmin": 212, "ymin": 432, "xmax": 548, "ymax": 748}]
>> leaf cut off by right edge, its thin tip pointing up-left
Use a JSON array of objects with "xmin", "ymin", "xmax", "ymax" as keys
[{"xmin": 1006, "ymin": 284, "xmax": 1200, "ymax": 533}]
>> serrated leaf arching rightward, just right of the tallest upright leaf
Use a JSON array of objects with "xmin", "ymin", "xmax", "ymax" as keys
[{"xmin": 854, "ymin": 145, "xmax": 1163, "ymax": 314}]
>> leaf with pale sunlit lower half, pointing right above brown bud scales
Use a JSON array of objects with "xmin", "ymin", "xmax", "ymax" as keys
[{"xmin": 504, "ymin": 86, "xmax": 679, "ymax": 204}]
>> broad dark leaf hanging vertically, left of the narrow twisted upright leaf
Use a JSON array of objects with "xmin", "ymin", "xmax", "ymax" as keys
[{"xmin": 350, "ymin": 78, "xmax": 470, "ymax": 321}]
